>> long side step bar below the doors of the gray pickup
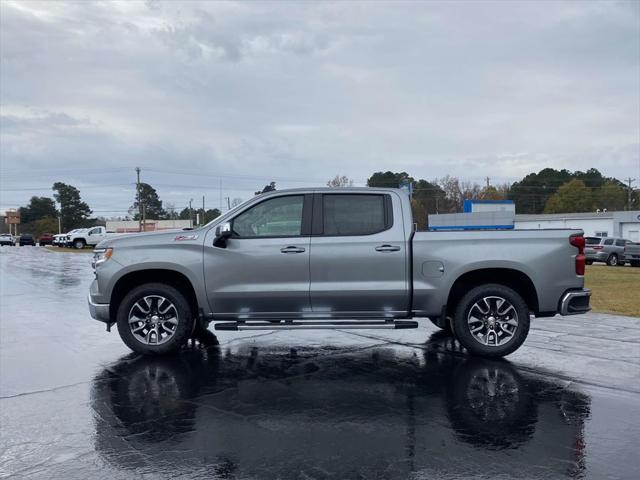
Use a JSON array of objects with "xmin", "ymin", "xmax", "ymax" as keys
[{"xmin": 213, "ymin": 320, "xmax": 418, "ymax": 331}]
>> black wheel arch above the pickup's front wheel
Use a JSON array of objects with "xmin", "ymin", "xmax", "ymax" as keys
[{"xmin": 109, "ymin": 268, "xmax": 199, "ymax": 322}]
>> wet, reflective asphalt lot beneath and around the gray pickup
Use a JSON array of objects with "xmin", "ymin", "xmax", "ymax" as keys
[{"xmin": 0, "ymin": 247, "xmax": 640, "ymax": 479}]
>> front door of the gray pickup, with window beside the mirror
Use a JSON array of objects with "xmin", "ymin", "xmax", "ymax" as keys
[{"xmin": 204, "ymin": 195, "xmax": 312, "ymax": 319}]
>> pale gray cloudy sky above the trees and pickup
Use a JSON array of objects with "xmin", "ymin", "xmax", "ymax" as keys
[{"xmin": 0, "ymin": 0, "xmax": 640, "ymax": 215}]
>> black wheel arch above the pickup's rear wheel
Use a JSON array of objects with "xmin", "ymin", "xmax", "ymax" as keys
[{"xmin": 447, "ymin": 268, "xmax": 539, "ymax": 314}]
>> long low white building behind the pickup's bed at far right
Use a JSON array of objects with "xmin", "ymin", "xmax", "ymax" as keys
[{"xmin": 514, "ymin": 210, "xmax": 640, "ymax": 242}]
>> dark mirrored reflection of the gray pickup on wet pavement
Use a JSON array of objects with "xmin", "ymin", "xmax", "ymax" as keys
[{"xmin": 92, "ymin": 333, "xmax": 589, "ymax": 478}]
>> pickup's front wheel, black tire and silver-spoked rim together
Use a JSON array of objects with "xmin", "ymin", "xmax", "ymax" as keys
[{"xmin": 117, "ymin": 283, "xmax": 194, "ymax": 355}]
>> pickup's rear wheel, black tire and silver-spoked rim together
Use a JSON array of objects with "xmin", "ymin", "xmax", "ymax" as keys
[{"xmin": 453, "ymin": 284, "xmax": 529, "ymax": 357}]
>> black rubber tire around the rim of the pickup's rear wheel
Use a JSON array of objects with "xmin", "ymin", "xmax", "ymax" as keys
[{"xmin": 453, "ymin": 283, "xmax": 529, "ymax": 357}]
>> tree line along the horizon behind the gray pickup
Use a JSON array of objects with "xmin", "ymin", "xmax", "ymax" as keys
[{"xmin": 10, "ymin": 168, "xmax": 640, "ymax": 235}]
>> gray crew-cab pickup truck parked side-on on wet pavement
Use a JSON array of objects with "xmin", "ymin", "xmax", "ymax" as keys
[{"xmin": 88, "ymin": 188, "xmax": 590, "ymax": 357}]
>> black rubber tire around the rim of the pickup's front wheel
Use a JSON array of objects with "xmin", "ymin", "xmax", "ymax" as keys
[{"xmin": 117, "ymin": 283, "xmax": 195, "ymax": 355}]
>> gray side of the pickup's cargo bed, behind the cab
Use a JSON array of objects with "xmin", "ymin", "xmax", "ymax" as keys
[{"xmin": 411, "ymin": 229, "xmax": 584, "ymax": 316}]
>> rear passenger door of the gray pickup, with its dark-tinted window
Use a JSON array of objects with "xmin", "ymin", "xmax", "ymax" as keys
[{"xmin": 310, "ymin": 192, "xmax": 409, "ymax": 317}]
